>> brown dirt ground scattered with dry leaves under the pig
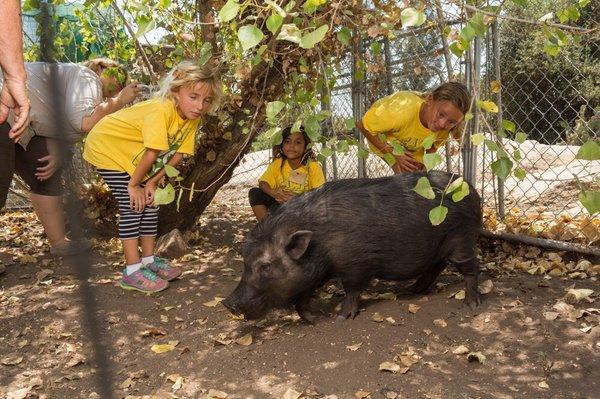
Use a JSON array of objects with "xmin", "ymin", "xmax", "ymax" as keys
[{"xmin": 0, "ymin": 188, "xmax": 600, "ymax": 399}]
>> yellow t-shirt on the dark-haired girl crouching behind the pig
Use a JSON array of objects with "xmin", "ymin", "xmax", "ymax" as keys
[{"xmin": 259, "ymin": 158, "xmax": 325, "ymax": 194}]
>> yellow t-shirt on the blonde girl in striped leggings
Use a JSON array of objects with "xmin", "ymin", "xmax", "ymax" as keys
[{"xmin": 83, "ymin": 99, "xmax": 200, "ymax": 176}]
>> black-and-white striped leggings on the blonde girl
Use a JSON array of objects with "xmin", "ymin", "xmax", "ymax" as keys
[{"xmin": 98, "ymin": 169, "xmax": 158, "ymax": 240}]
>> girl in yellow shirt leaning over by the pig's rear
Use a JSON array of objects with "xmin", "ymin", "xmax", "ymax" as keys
[{"xmin": 357, "ymin": 82, "xmax": 471, "ymax": 174}]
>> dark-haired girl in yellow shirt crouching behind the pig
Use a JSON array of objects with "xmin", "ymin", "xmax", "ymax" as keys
[{"xmin": 248, "ymin": 127, "xmax": 325, "ymax": 222}]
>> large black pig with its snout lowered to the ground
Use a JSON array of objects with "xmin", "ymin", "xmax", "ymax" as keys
[{"xmin": 223, "ymin": 171, "xmax": 482, "ymax": 322}]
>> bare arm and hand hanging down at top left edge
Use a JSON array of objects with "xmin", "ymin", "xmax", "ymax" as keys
[{"xmin": 0, "ymin": 0, "xmax": 29, "ymax": 140}]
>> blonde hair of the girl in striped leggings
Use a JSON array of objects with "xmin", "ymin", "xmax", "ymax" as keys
[{"xmin": 156, "ymin": 61, "xmax": 223, "ymax": 111}]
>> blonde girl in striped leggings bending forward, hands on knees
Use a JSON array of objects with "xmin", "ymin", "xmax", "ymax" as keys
[{"xmin": 83, "ymin": 61, "xmax": 221, "ymax": 293}]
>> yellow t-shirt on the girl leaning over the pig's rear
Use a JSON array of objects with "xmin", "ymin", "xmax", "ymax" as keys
[{"xmin": 362, "ymin": 91, "xmax": 448, "ymax": 162}]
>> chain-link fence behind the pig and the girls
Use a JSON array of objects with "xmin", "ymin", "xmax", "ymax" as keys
[{"xmin": 7, "ymin": 0, "xmax": 600, "ymax": 250}]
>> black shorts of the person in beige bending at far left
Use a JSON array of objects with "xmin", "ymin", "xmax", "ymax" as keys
[{"xmin": 0, "ymin": 124, "xmax": 64, "ymax": 206}]
